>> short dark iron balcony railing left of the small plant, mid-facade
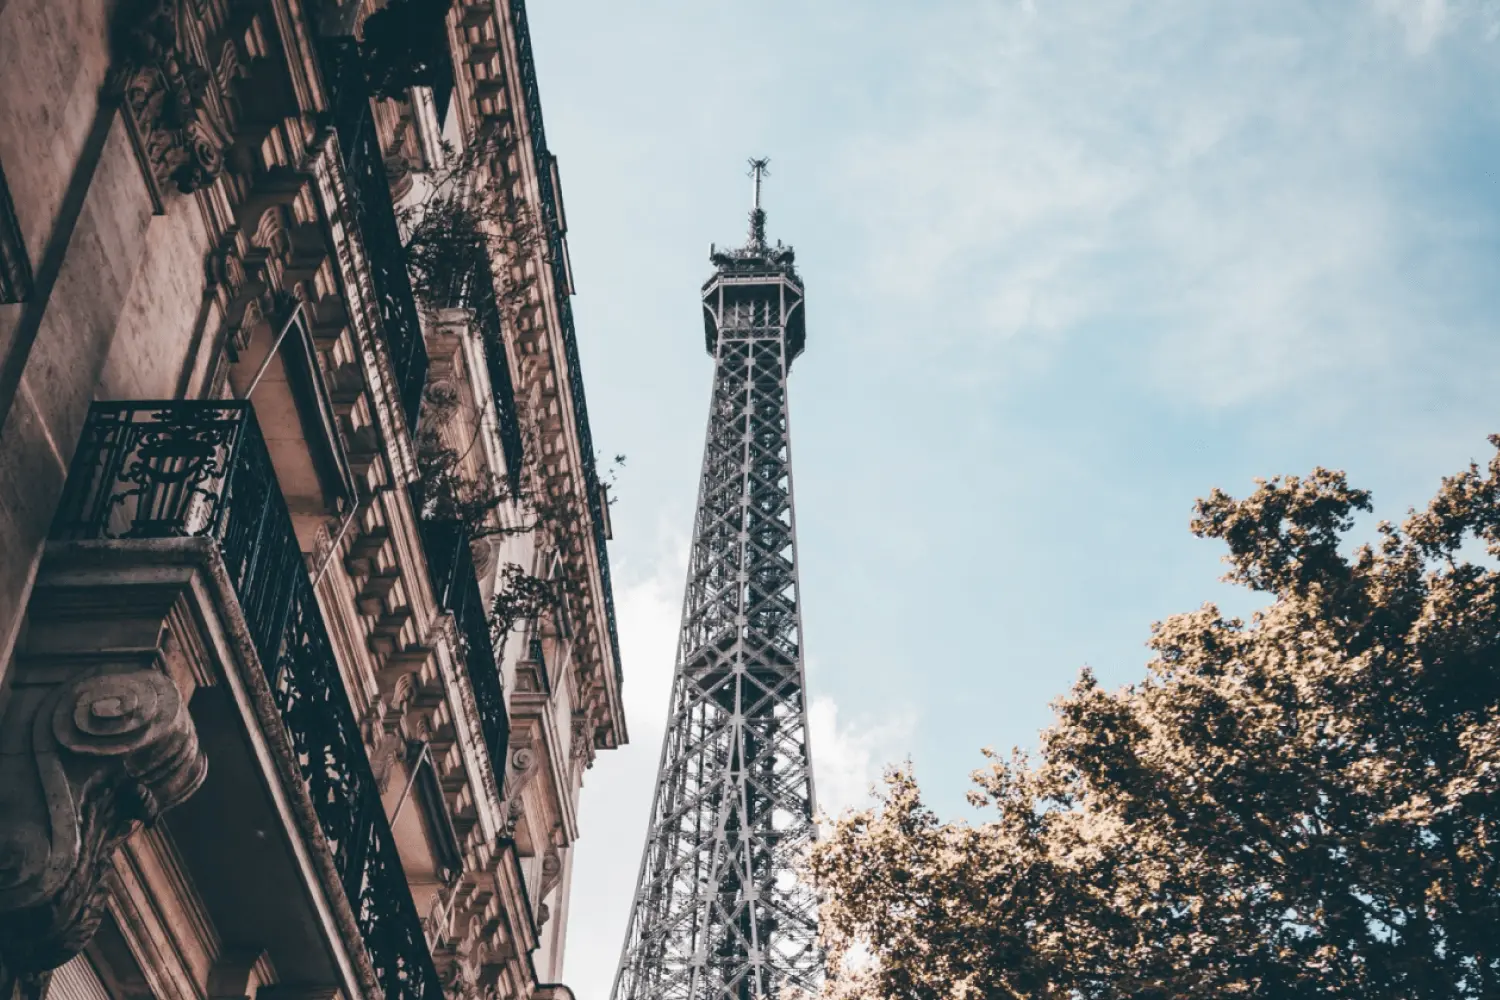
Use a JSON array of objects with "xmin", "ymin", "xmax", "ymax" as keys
[{"xmin": 422, "ymin": 520, "xmax": 510, "ymax": 795}]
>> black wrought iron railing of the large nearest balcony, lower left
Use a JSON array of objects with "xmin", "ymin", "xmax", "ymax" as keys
[{"xmin": 53, "ymin": 400, "xmax": 443, "ymax": 1000}]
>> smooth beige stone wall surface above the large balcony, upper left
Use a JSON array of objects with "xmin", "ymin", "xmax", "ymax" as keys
[{"xmin": 0, "ymin": 0, "xmax": 228, "ymax": 691}]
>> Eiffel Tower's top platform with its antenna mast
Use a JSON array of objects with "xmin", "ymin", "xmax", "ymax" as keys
[{"xmin": 704, "ymin": 160, "xmax": 807, "ymax": 363}]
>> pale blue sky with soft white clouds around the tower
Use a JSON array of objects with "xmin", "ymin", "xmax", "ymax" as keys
[{"xmin": 530, "ymin": 0, "xmax": 1500, "ymax": 1000}]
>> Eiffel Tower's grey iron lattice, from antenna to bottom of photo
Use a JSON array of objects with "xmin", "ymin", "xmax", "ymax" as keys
[{"xmin": 612, "ymin": 159, "xmax": 824, "ymax": 1000}]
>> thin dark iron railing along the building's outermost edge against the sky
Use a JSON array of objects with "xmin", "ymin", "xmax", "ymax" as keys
[{"xmin": 510, "ymin": 0, "xmax": 621, "ymax": 679}]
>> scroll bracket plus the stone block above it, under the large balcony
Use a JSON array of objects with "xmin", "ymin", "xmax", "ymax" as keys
[{"xmin": 0, "ymin": 576, "xmax": 207, "ymax": 973}]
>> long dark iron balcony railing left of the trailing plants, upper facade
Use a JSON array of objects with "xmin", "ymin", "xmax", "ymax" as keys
[{"xmin": 321, "ymin": 37, "xmax": 428, "ymax": 432}]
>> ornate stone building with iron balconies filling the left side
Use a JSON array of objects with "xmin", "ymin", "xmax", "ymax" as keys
[{"xmin": 0, "ymin": 0, "xmax": 627, "ymax": 1000}]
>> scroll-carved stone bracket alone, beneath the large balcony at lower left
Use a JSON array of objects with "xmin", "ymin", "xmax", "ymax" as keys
[{"xmin": 0, "ymin": 664, "xmax": 207, "ymax": 973}]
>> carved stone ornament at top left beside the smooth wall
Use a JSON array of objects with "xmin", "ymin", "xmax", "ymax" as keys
[{"xmin": 113, "ymin": 0, "xmax": 230, "ymax": 196}]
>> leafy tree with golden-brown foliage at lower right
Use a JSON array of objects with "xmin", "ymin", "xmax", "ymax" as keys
[{"xmin": 809, "ymin": 436, "xmax": 1500, "ymax": 1000}]
